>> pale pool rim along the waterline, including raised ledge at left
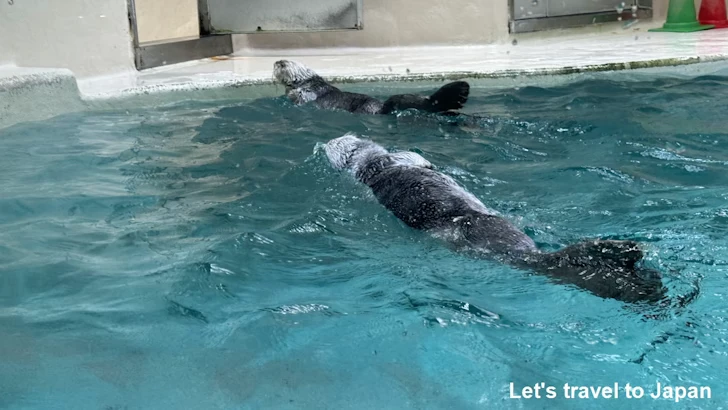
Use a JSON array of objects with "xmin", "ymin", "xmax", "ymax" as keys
[{"xmin": 0, "ymin": 54, "xmax": 728, "ymax": 128}]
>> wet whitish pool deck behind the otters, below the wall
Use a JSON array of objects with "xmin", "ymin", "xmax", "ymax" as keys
[{"xmin": 84, "ymin": 23, "xmax": 728, "ymax": 98}]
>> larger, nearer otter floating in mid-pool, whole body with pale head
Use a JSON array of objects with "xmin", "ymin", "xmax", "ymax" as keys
[{"xmin": 325, "ymin": 134, "xmax": 666, "ymax": 302}]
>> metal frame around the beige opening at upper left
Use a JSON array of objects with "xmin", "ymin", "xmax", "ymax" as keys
[{"xmin": 127, "ymin": 0, "xmax": 233, "ymax": 70}]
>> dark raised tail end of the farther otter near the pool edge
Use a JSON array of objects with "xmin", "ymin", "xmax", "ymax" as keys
[{"xmin": 381, "ymin": 81, "xmax": 470, "ymax": 114}]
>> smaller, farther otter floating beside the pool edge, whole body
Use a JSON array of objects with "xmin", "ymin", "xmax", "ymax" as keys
[{"xmin": 273, "ymin": 60, "xmax": 470, "ymax": 114}]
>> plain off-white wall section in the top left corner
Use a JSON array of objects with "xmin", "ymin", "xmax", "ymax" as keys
[{"xmin": 0, "ymin": 0, "xmax": 134, "ymax": 77}]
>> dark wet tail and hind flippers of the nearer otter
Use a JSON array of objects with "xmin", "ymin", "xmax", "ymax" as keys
[{"xmin": 528, "ymin": 240, "xmax": 667, "ymax": 303}]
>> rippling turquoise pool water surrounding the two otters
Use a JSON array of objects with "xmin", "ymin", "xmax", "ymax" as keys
[{"xmin": 0, "ymin": 77, "xmax": 728, "ymax": 410}]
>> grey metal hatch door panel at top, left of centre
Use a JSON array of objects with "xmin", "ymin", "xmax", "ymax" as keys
[{"xmin": 199, "ymin": 0, "xmax": 363, "ymax": 34}]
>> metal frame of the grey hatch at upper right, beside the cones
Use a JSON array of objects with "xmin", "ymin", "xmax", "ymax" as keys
[{"xmin": 508, "ymin": 0, "xmax": 652, "ymax": 33}]
